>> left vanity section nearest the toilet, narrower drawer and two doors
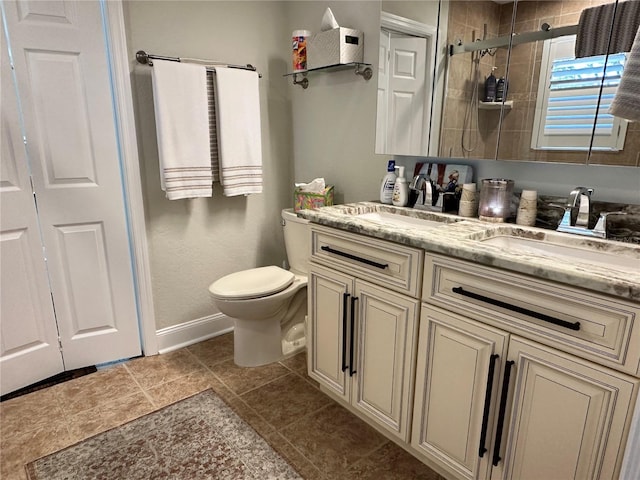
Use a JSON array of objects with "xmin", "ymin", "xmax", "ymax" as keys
[{"xmin": 307, "ymin": 229, "xmax": 422, "ymax": 442}]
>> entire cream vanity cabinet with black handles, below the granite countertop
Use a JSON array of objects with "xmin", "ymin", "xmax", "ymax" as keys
[{"xmin": 307, "ymin": 225, "xmax": 640, "ymax": 480}]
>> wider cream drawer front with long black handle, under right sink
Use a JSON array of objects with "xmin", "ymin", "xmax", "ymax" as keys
[{"xmin": 422, "ymin": 254, "xmax": 640, "ymax": 376}]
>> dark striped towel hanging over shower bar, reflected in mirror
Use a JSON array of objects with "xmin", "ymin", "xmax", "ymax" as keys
[{"xmin": 575, "ymin": 0, "xmax": 640, "ymax": 58}]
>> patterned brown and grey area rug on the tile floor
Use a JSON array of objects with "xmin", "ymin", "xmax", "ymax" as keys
[{"xmin": 26, "ymin": 390, "xmax": 301, "ymax": 480}]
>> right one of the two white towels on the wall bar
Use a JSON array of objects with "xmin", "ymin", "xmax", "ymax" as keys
[{"xmin": 215, "ymin": 67, "xmax": 262, "ymax": 196}]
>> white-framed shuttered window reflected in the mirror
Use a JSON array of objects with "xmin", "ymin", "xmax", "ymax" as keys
[{"xmin": 531, "ymin": 35, "xmax": 627, "ymax": 151}]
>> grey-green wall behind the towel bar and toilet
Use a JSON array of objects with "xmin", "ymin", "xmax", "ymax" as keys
[{"xmin": 125, "ymin": 0, "xmax": 293, "ymax": 329}]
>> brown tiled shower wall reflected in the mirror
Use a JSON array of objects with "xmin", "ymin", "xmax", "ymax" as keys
[{"xmin": 441, "ymin": 0, "xmax": 640, "ymax": 166}]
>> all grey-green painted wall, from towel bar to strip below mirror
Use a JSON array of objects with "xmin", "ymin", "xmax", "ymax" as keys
[{"xmin": 125, "ymin": 0, "xmax": 640, "ymax": 328}]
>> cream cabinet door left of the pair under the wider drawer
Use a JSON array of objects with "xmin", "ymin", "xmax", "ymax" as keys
[{"xmin": 411, "ymin": 305, "xmax": 510, "ymax": 480}]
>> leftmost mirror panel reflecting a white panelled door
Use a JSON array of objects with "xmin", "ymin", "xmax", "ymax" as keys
[{"xmin": 375, "ymin": 1, "xmax": 443, "ymax": 156}]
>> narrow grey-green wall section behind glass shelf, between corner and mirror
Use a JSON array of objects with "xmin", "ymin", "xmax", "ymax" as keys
[{"xmin": 287, "ymin": 1, "xmax": 388, "ymax": 203}]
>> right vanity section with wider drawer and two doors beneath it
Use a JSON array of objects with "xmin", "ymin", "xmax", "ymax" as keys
[{"xmin": 411, "ymin": 255, "xmax": 640, "ymax": 480}]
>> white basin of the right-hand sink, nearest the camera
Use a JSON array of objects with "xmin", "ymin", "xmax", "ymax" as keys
[{"xmin": 482, "ymin": 235, "xmax": 640, "ymax": 273}]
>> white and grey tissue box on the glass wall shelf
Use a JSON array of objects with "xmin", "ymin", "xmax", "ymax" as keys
[{"xmin": 307, "ymin": 27, "xmax": 364, "ymax": 69}]
